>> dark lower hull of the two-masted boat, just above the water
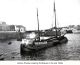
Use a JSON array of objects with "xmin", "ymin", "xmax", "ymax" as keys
[{"xmin": 20, "ymin": 37, "xmax": 68, "ymax": 52}]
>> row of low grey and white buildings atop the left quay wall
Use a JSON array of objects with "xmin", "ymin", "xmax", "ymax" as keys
[{"xmin": 0, "ymin": 22, "xmax": 26, "ymax": 32}]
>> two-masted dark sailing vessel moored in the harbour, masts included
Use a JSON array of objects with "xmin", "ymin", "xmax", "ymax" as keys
[{"xmin": 20, "ymin": 2, "xmax": 68, "ymax": 52}]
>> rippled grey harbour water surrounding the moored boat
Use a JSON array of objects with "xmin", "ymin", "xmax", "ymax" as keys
[{"xmin": 0, "ymin": 34, "xmax": 80, "ymax": 60}]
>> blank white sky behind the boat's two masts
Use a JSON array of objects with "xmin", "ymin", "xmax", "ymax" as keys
[{"xmin": 0, "ymin": 0, "xmax": 80, "ymax": 30}]
